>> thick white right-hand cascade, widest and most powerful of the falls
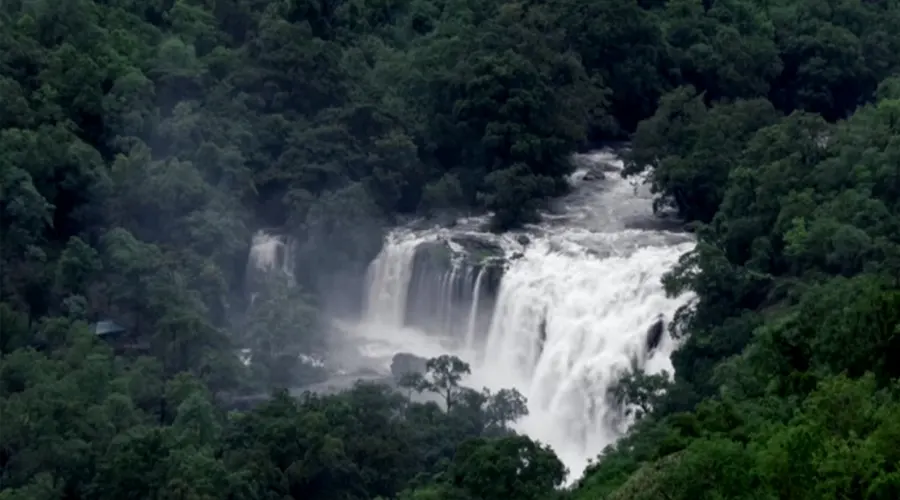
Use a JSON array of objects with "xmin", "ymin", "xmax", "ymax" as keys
[{"xmin": 475, "ymin": 234, "xmax": 693, "ymax": 475}]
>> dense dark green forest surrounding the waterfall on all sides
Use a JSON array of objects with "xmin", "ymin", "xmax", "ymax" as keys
[{"xmin": 0, "ymin": 0, "xmax": 900, "ymax": 500}]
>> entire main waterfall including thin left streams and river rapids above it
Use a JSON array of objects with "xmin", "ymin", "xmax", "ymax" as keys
[{"xmin": 355, "ymin": 152, "xmax": 694, "ymax": 478}]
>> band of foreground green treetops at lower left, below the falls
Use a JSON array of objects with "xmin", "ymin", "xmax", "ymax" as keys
[{"xmin": 0, "ymin": 346, "xmax": 544, "ymax": 499}]
